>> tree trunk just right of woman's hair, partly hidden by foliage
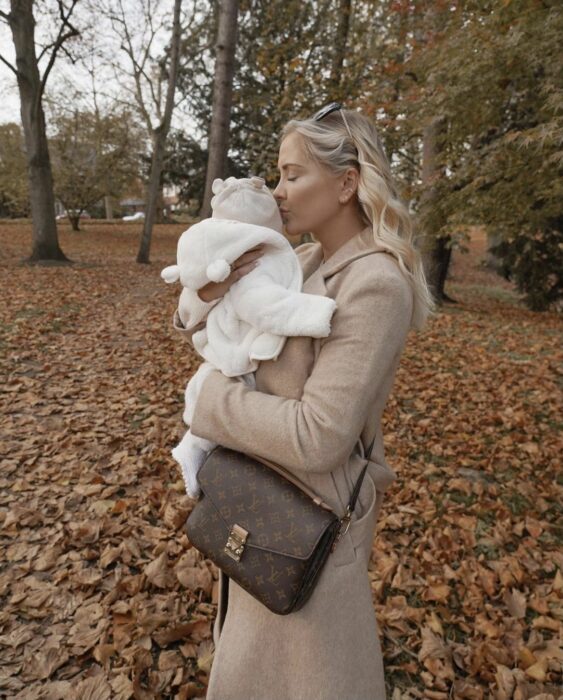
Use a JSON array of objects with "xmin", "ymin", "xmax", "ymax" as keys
[{"xmin": 421, "ymin": 117, "xmax": 452, "ymax": 304}]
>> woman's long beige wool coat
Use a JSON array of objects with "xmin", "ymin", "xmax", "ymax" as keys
[{"xmin": 174, "ymin": 228, "xmax": 413, "ymax": 700}]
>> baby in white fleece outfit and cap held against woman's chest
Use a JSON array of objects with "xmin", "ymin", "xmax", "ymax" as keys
[{"xmin": 161, "ymin": 177, "xmax": 336, "ymax": 498}]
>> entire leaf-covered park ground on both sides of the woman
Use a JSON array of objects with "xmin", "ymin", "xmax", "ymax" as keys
[{"xmin": 0, "ymin": 222, "xmax": 563, "ymax": 700}]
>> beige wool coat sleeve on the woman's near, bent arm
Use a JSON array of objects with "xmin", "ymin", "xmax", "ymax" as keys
[{"xmin": 191, "ymin": 263, "xmax": 413, "ymax": 472}]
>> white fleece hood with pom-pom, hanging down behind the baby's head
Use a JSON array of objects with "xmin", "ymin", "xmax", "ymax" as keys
[{"xmin": 160, "ymin": 218, "xmax": 301, "ymax": 290}]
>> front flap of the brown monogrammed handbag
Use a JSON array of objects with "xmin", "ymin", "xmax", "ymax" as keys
[{"xmin": 197, "ymin": 446, "xmax": 338, "ymax": 559}]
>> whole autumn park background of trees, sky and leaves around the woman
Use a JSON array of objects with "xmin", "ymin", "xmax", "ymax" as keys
[{"xmin": 0, "ymin": 0, "xmax": 563, "ymax": 700}]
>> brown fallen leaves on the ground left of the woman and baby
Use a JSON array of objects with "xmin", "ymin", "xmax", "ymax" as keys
[{"xmin": 0, "ymin": 221, "xmax": 213, "ymax": 700}]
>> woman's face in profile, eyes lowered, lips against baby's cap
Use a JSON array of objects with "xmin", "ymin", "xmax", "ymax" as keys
[{"xmin": 273, "ymin": 132, "xmax": 342, "ymax": 236}]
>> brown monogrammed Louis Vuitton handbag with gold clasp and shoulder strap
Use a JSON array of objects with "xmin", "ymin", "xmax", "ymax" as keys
[{"xmin": 185, "ymin": 438, "xmax": 375, "ymax": 615}]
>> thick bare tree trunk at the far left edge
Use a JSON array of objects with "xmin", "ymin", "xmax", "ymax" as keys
[{"xmin": 9, "ymin": 0, "xmax": 68, "ymax": 261}]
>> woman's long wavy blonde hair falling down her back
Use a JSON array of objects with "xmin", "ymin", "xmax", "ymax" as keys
[{"xmin": 280, "ymin": 109, "xmax": 435, "ymax": 330}]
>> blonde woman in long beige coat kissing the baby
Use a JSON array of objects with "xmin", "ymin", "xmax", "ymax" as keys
[{"xmin": 175, "ymin": 103, "xmax": 432, "ymax": 700}]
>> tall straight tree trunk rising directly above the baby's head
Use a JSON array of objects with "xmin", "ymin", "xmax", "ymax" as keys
[{"xmin": 199, "ymin": 0, "xmax": 238, "ymax": 219}]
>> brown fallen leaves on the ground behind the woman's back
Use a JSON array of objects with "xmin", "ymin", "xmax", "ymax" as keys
[{"xmin": 382, "ymin": 231, "xmax": 563, "ymax": 700}]
